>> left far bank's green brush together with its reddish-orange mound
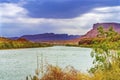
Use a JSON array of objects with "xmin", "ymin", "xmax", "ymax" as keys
[{"xmin": 0, "ymin": 37, "xmax": 52, "ymax": 49}]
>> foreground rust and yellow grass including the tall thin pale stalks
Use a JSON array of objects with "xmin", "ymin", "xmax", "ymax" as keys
[{"xmin": 26, "ymin": 50, "xmax": 120, "ymax": 80}]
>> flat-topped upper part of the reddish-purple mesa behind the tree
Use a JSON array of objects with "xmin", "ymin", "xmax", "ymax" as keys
[{"xmin": 83, "ymin": 23, "xmax": 120, "ymax": 38}]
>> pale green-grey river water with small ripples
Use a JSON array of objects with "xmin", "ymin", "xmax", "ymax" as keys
[{"xmin": 0, "ymin": 46, "xmax": 92, "ymax": 80}]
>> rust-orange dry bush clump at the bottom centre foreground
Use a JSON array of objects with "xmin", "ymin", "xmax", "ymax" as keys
[{"xmin": 41, "ymin": 66, "xmax": 90, "ymax": 80}]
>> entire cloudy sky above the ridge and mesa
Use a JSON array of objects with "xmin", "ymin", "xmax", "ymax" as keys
[{"xmin": 0, "ymin": 0, "xmax": 120, "ymax": 37}]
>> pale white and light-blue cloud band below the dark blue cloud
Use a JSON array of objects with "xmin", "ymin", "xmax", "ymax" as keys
[{"xmin": 0, "ymin": 3, "xmax": 120, "ymax": 36}]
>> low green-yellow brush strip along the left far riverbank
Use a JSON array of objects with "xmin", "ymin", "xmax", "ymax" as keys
[{"xmin": 0, "ymin": 42, "xmax": 53, "ymax": 50}]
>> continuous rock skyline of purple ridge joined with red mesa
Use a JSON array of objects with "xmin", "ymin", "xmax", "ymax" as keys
[{"xmin": 9, "ymin": 22, "xmax": 120, "ymax": 44}]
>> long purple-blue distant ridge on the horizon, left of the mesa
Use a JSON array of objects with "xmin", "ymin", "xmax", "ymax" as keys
[{"xmin": 11, "ymin": 33, "xmax": 80, "ymax": 42}]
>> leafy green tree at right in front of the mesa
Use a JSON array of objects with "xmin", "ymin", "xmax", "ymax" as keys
[{"xmin": 90, "ymin": 27, "xmax": 119, "ymax": 72}]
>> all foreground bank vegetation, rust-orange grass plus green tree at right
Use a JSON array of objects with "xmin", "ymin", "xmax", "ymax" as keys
[{"xmin": 26, "ymin": 27, "xmax": 120, "ymax": 80}]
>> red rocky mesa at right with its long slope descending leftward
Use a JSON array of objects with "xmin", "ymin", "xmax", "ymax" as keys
[{"xmin": 72, "ymin": 23, "xmax": 120, "ymax": 44}]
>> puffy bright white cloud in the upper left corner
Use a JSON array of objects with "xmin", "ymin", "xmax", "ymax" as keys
[{"xmin": 0, "ymin": 3, "xmax": 27, "ymax": 23}]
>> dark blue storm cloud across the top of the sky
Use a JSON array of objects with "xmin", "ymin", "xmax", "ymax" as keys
[{"xmin": 24, "ymin": 0, "xmax": 120, "ymax": 18}]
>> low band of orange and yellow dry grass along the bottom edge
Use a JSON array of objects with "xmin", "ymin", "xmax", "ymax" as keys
[{"xmin": 27, "ymin": 64, "xmax": 120, "ymax": 80}]
